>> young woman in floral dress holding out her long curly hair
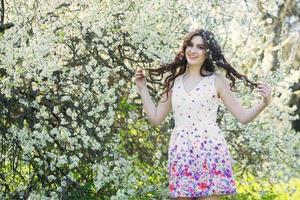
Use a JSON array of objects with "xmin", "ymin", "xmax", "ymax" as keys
[{"xmin": 135, "ymin": 29, "xmax": 272, "ymax": 200}]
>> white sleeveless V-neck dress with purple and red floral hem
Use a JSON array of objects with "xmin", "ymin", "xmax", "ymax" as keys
[{"xmin": 168, "ymin": 72, "xmax": 237, "ymax": 198}]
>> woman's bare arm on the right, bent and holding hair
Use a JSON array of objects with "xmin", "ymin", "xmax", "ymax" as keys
[{"xmin": 215, "ymin": 73, "xmax": 271, "ymax": 124}]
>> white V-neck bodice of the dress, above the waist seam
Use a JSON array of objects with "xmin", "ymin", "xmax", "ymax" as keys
[{"xmin": 172, "ymin": 73, "xmax": 219, "ymax": 130}]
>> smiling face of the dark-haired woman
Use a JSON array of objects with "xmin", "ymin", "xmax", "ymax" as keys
[{"xmin": 185, "ymin": 35, "xmax": 206, "ymax": 65}]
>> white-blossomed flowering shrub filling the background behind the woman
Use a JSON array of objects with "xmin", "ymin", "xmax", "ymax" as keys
[{"xmin": 0, "ymin": 0, "xmax": 300, "ymax": 199}]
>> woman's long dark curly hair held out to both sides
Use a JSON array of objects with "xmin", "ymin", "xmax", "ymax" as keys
[{"xmin": 145, "ymin": 29, "xmax": 258, "ymax": 101}]
